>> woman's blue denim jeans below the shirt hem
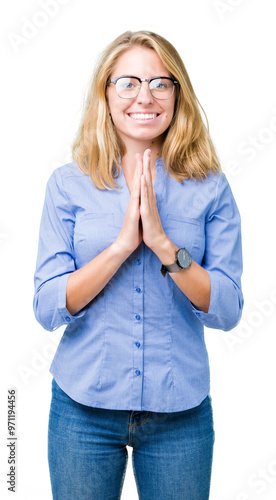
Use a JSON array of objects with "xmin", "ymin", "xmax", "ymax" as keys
[{"xmin": 48, "ymin": 380, "xmax": 214, "ymax": 500}]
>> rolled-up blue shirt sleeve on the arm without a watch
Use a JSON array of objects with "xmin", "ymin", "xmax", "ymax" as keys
[{"xmin": 33, "ymin": 169, "xmax": 85, "ymax": 331}]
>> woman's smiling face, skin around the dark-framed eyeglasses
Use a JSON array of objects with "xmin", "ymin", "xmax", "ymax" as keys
[{"xmin": 107, "ymin": 46, "xmax": 175, "ymax": 149}]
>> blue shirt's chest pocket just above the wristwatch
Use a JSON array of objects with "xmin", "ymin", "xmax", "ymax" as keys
[{"xmin": 163, "ymin": 214, "xmax": 205, "ymax": 261}]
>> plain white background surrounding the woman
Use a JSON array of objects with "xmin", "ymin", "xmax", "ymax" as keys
[{"xmin": 0, "ymin": 0, "xmax": 276, "ymax": 500}]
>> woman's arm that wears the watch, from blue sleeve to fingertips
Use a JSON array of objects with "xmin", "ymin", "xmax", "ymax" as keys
[{"xmin": 139, "ymin": 147, "xmax": 243, "ymax": 330}]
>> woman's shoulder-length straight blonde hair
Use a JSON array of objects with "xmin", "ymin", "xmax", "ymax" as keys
[{"xmin": 72, "ymin": 31, "xmax": 221, "ymax": 189}]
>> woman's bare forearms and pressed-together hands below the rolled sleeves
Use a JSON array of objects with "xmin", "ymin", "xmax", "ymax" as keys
[{"xmin": 66, "ymin": 149, "xmax": 211, "ymax": 315}]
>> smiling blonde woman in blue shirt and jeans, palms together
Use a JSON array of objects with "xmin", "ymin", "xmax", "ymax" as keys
[{"xmin": 34, "ymin": 31, "xmax": 243, "ymax": 500}]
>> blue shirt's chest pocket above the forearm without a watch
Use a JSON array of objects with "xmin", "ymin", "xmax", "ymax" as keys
[{"xmin": 74, "ymin": 212, "xmax": 124, "ymax": 267}]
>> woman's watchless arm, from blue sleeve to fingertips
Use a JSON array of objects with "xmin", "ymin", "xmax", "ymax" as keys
[{"xmin": 34, "ymin": 161, "xmax": 141, "ymax": 330}]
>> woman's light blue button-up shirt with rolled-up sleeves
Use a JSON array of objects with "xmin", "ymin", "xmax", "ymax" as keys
[{"xmin": 34, "ymin": 159, "xmax": 243, "ymax": 412}]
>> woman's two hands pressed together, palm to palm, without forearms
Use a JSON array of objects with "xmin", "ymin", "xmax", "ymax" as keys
[{"xmin": 117, "ymin": 149, "xmax": 168, "ymax": 253}]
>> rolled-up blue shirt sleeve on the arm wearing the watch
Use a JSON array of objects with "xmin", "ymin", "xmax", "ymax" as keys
[{"xmin": 192, "ymin": 174, "xmax": 243, "ymax": 331}]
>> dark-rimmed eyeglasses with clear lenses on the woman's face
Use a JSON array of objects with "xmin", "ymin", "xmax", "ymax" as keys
[{"xmin": 109, "ymin": 76, "xmax": 178, "ymax": 99}]
